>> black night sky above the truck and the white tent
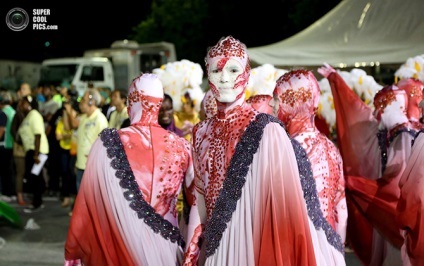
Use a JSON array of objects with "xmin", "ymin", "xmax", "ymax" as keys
[{"xmin": 0, "ymin": 0, "xmax": 340, "ymax": 63}]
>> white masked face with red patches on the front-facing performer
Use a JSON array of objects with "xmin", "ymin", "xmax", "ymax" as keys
[{"xmin": 209, "ymin": 57, "xmax": 248, "ymax": 103}]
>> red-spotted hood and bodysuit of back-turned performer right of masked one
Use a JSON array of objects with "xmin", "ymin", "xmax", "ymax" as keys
[{"xmin": 274, "ymin": 69, "xmax": 348, "ymax": 242}]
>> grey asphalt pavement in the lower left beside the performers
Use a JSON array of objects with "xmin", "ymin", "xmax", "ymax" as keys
[{"xmin": 0, "ymin": 194, "xmax": 361, "ymax": 266}]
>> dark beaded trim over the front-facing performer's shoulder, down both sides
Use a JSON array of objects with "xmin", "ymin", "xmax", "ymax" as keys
[{"xmin": 204, "ymin": 113, "xmax": 344, "ymax": 257}]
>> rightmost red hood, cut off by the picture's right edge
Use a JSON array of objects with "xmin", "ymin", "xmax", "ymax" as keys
[{"xmin": 396, "ymin": 78, "xmax": 424, "ymax": 122}]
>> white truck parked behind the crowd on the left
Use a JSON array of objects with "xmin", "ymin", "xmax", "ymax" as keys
[{"xmin": 40, "ymin": 40, "xmax": 176, "ymax": 96}]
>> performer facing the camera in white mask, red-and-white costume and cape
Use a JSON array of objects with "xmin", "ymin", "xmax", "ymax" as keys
[{"xmin": 184, "ymin": 36, "xmax": 345, "ymax": 265}]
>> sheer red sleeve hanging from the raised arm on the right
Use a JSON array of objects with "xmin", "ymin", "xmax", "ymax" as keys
[{"xmin": 328, "ymin": 72, "xmax": 381, "ymax": 179}]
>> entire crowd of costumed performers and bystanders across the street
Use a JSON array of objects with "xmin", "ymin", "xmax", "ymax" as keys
[{"xmin": 0, "ymin": 36, "xmax": 424, "ymax": 265}]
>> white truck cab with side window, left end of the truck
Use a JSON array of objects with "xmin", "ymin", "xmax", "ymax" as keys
[{"xmin": 39, "ymin": 57, "xmax": 115, "ymax": 96}]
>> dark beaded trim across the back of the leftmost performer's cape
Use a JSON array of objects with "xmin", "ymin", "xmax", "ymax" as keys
[{"xmin": 100, "ymin": 128, "xmax": 185, "ymax": 247}]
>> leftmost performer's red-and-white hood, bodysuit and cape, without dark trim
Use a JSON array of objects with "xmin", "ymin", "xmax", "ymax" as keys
[{"xmin": 65, "ymin": 74, "xmax": 194, "ymax": 265}]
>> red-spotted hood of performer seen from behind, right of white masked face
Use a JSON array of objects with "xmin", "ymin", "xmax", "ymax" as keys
[{"xmin": 274, "ymin": 69, "xmax": 320, "ymax": 123}]
